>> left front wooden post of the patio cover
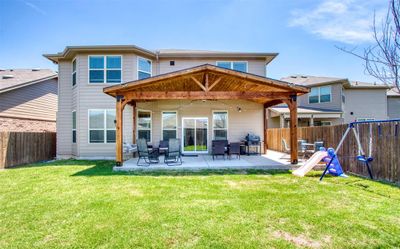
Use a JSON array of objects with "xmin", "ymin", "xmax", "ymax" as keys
[{"xmin": 115, "ymin": 95, "xmax": 124, "ymax": 166}]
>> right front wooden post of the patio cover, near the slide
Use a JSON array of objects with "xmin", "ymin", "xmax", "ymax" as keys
[{"xmin": 287, "ymin": 95, "xmax": 298, "ymax": 164}]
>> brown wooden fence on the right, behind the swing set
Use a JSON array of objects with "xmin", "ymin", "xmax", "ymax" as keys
[{"xmin": 267, "ymin": 123, "xmax": 400, "ymax": 184}]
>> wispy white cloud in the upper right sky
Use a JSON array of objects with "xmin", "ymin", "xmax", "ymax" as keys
[{"xmin": 289, "ymin": 0, "xmax": 387, "ymax": 44}]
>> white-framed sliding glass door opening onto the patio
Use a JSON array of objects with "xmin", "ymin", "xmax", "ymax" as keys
[{"xmin": 182, "ymin": 118, "xmax": 208, "ymax": 153}]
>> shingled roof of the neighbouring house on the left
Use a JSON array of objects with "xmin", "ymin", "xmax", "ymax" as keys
[{"xmin": 0, "ymin": 69, "xmax": 57, "ymax": 93}]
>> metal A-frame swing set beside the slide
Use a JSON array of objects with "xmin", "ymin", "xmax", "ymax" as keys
[{"xmin": 319, "ymin": 119, "xmax": 400, "ymax": 181}]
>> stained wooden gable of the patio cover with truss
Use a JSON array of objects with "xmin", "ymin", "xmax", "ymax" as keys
[{"xmin": 103, "ymin": 64, "xmax": 309, "ymax": 104}]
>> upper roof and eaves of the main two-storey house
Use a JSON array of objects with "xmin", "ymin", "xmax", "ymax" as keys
[{"xmin": 43, "ymin": 45, "xmax": 278, "ymax": 64}]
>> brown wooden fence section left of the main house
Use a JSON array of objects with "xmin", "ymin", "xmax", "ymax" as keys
[{"xmin": 0, "ymin": 132, "xmax": 56, "ymax": 168}]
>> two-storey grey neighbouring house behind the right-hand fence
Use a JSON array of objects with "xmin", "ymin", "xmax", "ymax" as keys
[{"xmin": 269, "ymin": 75, "xmax": 389, "ymax": 127}]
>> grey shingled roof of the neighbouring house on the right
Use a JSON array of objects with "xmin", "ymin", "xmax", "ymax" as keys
[{"xmin": 282, "ymin": 75, "xmax": 390, "ymax": 89}]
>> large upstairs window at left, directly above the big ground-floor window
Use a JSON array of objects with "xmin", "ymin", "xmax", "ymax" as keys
[{"xmin": 89, "ymin": 55, "xmax": 122, "ymax": 83}]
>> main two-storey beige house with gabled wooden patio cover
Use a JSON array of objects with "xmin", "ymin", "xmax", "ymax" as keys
[{"xmin": 44, "ymin": 45, "xmax": 308, "ymax": 161}]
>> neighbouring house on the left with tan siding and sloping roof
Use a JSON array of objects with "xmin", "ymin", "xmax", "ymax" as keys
[{"xmin": 0, "ymin": 69, "xmax": 58, "ymax": 132}]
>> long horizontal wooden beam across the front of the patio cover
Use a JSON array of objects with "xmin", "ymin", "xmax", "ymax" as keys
[{"xmin": 120, "ymin": 91, "xmax": 289, "ymax": 100}]
